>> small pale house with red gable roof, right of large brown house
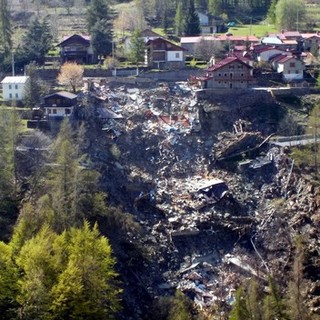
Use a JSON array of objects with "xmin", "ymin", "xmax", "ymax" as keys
[{"xmin": 270, "ymin": 54, "xmax": 305, "ymax": 82}]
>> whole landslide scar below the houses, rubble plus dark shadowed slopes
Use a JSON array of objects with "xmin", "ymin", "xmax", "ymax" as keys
[{"xmin": 21, "ymin": 80, "xmax": 320, "ymax": 319}]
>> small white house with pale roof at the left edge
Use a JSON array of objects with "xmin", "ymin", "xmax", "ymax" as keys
[{"xmin": 1, "ymin": 76, "xmax": 29, "ymax": 101}]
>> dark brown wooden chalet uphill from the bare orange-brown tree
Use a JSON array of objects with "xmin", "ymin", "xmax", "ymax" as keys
[{"xmin": 57, "ymin": 34, "xmax": 96, "ymax": 64}]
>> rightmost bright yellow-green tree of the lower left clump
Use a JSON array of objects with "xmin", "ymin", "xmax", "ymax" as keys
[{"xmin": 51, "ymin": 222, "xmax": 121, "ymax": 320}]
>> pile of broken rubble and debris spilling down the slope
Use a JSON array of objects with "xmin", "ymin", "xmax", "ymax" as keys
[{"xmin": 78, "ymin": 79, "xmax": 320, "ymax": 318}]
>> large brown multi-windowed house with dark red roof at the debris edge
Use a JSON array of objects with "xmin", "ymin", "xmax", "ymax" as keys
[{"xmin": 198, "ymin": 57, "xmax": 253, "ymax": 89}]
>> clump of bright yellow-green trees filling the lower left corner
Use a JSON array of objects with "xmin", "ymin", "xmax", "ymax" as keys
[{"xmin": 9, "ymin": 222, "xmax": 121, "ymax": 320}]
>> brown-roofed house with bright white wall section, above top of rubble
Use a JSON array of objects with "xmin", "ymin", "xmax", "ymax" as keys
[{"xmin": 145, "ymin": 37, "xmax": 186, "ymax": 69}]
